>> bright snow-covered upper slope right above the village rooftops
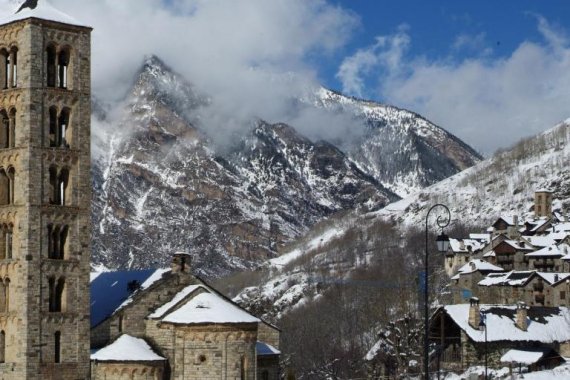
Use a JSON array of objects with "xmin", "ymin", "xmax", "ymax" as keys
[{"xmin": 374, "ymin": 120, "xmax": 570, "ymax": 226}]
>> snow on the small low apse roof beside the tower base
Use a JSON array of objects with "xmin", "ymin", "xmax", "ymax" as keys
[{"xmin": 91, "ymin": 335, "xmax": 166, "ymax": 362}]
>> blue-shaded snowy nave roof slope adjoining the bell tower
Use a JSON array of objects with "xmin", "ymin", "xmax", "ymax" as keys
[{"xmin": 90, "ymin": 269, "xmax": 170, "ymax": 327}]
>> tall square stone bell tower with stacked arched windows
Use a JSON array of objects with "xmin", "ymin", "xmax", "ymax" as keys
[{"xmin": 0, "ymin": 0, "xmax": 91, "ymax": 380}]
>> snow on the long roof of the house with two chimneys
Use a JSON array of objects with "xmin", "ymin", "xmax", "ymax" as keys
[{"xmin": 443, "ymin": 304, "xmax": 570, "ymax": 343}]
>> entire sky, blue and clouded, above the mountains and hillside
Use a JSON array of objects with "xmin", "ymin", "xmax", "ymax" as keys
[{"xmin": 45, "ymin": 0, "xmax": 570, "ymax": 154}]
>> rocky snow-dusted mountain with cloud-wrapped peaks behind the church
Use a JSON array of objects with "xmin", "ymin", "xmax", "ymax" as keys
[{"xmin": 93, "ymin": 57, "xmax": 479, "ymax": 276}]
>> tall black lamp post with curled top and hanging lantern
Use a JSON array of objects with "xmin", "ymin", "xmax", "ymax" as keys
[{"xmin": 424, "ymin": 203, "xmax": 451, "ymax": 380}]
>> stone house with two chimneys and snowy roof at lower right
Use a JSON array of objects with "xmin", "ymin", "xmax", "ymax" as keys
[{"xmin": 429, "ymin": 298, "xmax": 570, "ymax": 372}]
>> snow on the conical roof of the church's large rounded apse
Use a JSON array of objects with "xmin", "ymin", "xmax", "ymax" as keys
[{"xmin": 162, "ymin": 293, "xmax": 260, "ymax": 324}]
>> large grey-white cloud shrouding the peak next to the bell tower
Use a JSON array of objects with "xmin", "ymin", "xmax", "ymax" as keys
[{"xmin": 10, "ymin": 0, "xmax": 359, "ymax": 144}]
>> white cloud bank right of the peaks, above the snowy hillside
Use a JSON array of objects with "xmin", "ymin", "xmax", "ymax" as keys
[{"xmin": 338, "ymin": 16, "xmax": 570, "ymax": 154}]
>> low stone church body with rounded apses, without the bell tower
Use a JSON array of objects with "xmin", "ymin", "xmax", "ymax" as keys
[{"xmin": 91, "ymin": 253, "xmax": 280, "ymax": 380}]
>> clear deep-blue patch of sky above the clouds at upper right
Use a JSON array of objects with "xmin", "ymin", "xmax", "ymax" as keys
[{"xmin": 320, "ymin": 0, "xmax": 570, "ymax": 100}]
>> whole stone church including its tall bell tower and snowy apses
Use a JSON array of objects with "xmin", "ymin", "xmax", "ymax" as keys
[{"xmin": 0, "ymin": 0, "xmax": 279, "ymax": 380}]
